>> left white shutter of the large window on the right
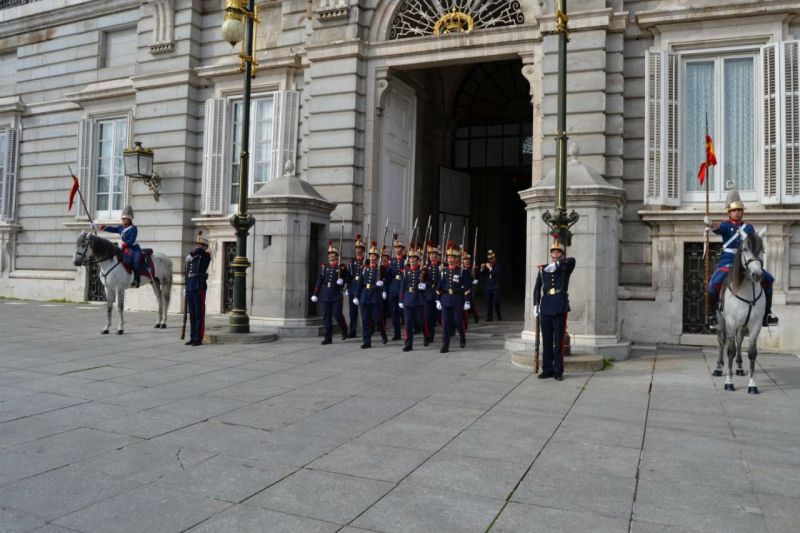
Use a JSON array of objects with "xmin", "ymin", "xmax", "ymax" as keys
[{"xmin": 644, "ymin": 50, "xmax": 680, "ymax": 205}]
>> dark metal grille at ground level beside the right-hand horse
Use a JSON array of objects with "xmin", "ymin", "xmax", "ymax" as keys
[{"xmin": 683, "ymin": 242, "xmax": 722, "ymax": 335}]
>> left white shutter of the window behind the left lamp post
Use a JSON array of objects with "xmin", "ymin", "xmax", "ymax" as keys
[{"xmin": 202, "ymin": 98, "xmax": 226, "ymax": 214}]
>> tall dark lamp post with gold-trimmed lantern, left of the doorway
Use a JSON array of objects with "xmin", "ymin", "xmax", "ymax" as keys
[{"xmin": 222, "ymin": 0, "xmax": 258, "ymax": 333}]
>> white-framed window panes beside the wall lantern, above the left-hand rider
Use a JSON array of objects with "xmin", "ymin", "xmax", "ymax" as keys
[{"xmin": 94, "ymin": 119, "xmax": 128, "ymax": 219}]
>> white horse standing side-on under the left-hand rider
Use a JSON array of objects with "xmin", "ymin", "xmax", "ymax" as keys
[{"xmin": 72, "ymin": 231, "xmax": 172, "ymax": 335}]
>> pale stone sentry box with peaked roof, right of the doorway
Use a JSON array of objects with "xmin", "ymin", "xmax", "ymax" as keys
[{"xmin": 506, "ymin": 145, "xmax": 630, "ymax": 359}]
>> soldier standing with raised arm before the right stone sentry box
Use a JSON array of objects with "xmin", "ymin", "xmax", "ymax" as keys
[{"xmin": 533, "ymin": 241, "xmax": 575, "ymax": 381}]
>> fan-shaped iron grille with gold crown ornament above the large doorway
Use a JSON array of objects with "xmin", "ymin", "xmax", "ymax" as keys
[{"xmin": 388, "ymin": 0, "xmax": 525, "ymax": 40}]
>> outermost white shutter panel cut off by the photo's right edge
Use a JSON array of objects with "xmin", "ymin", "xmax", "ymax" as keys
[{"xmin": 779, "ymin": 41, "xmax": 800, "ymax": 204}]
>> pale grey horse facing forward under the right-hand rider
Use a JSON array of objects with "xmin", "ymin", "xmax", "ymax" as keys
[{"xmin": 714, "ymin": 230, "xmax": 766, "ymax": 394}]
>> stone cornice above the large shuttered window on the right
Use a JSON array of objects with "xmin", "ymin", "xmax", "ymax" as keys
[{"xmin": 636, "ymin": 0, "xmax": 800, "ymax": 29}]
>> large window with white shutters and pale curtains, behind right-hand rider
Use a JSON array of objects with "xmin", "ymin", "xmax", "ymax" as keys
[{"xmin": 644, "ymin": 41, "xmax": 800, "ymax": 206}]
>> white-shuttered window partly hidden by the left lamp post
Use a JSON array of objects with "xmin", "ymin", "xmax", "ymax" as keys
[{"xmin": 202, "ymin": 91, "xmax": 300, "ymax": 214}]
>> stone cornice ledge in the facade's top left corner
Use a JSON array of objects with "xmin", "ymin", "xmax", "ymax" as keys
[{"xmin": 0, "ymin": 0, "xmax": 141, "ymax": 38}]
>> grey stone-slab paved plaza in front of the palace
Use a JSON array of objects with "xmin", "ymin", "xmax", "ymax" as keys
[{"xmin": 0, "ymin": 300, "xmax": 800, "ymax": 533}]
